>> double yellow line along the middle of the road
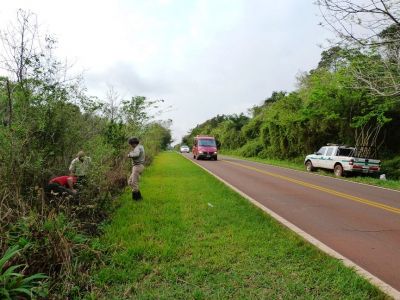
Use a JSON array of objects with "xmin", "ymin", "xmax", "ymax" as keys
[{"xmin": 223, "ymin": 160, "xmax": 400, "ymax": 214}]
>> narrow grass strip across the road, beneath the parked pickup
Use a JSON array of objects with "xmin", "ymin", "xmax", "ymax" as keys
[{"xmin": 220, "ymin": 151, "xmax": 400, "ymax": 190}]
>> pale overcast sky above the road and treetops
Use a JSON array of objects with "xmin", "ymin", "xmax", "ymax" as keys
[{"xmin": 0, "ymin": 0, "xmax": 329, "ymax": 142}]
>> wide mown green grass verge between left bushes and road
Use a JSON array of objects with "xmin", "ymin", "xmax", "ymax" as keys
[{"xmin": 87, "ymin": 152, "xmax": 385, "ymax": 299}]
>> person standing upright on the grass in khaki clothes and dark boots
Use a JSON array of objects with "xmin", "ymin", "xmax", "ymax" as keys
[{"xmin": 128, "ymin": 137, "xmax": 145, "ymax": 200}]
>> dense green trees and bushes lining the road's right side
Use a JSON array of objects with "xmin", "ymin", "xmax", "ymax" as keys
[{"xmin": 182, "ymin": 47, "xmax": 400, "ymax": 178}]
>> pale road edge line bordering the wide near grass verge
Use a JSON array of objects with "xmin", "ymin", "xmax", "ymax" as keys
[{"xmin": 182, "ymin": 155, "xmax": 400, "ymax": 300}]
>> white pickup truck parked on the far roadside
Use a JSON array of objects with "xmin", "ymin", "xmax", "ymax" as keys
[{"xmin": 304, "ymin": 144, "xmax": 381, "ymax": 177}]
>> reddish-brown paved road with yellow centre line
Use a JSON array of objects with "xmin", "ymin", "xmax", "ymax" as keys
[{"xmin": 187, "ymin": 154, "xmax": 400, "ymax": 291}]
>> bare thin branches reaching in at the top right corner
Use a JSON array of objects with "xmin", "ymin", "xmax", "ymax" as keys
[{"xmin": 316, "ymin": 0, "xmax": 400, "ymax": 97}]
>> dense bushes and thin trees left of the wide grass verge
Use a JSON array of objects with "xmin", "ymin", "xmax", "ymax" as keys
[{"xmin": 0, "ymin": 11, "xmax": 171, "ymax": 298}]
